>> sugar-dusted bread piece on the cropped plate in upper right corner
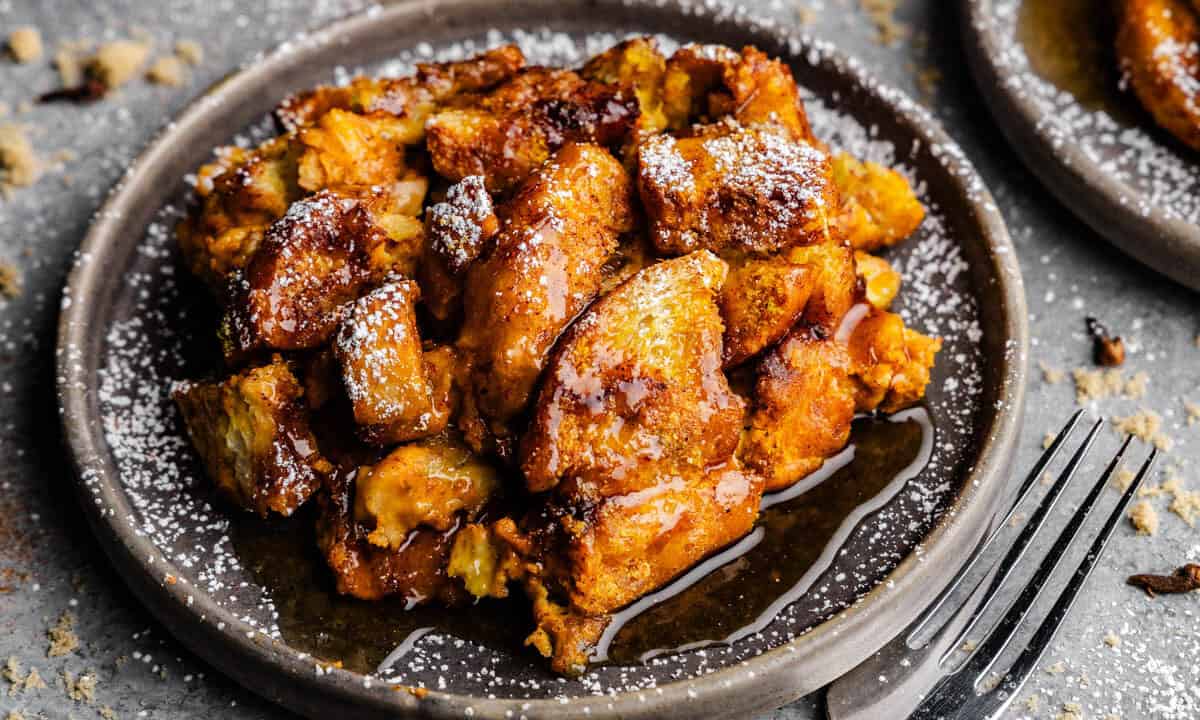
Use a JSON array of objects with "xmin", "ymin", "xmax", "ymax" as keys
[{"xmin": 1116, "ymin": 0, "xmax": 1200, "ymax": 150}]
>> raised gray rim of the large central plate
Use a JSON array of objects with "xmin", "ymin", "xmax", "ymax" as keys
[{"xmin": 56, "ymin": 0, "xmax": 1028, "ymax": 718}]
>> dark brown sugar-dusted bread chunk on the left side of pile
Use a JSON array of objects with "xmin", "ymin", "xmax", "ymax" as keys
[{"xmin": 221, "ymin": 192, "xmax": 389, "ymax": 358}]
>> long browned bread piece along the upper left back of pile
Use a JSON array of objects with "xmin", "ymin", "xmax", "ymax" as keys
[{"xmin": 275, "ymin": 46, "xmax": 524, "ymax": 133}]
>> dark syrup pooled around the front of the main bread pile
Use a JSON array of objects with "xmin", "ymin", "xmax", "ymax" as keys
[{"xmin": 233, "ymin": 408, "xmax": 934, "ymax": 672}]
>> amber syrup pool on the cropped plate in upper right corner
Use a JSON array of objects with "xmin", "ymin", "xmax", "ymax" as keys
[{"xmin": 1016, "ymin": 0, "xmax": 1135, "ymax": 124}]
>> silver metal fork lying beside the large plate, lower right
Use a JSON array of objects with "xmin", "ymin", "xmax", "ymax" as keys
[{"xmin": 827, "ymin": 410, "xmax": 1158, "ymax": 720}]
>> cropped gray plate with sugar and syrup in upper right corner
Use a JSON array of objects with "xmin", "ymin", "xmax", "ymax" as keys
[{"xmin": 962, "ymin": 0, "xmax": 1200, "ymax": 289}]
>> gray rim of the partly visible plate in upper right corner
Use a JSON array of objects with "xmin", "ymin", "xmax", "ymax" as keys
[{"xmin": 960, "ymin": 0, "xmax": 1200, "ymax": 290}]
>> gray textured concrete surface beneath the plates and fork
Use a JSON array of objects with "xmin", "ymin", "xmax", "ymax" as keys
[{"xmin": 0, "ymin": 0, "xmax": 1200, "ymax": 719}]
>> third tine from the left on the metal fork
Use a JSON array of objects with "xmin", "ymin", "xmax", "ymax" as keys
[{"xmin": 964, "ymin": 437, "xmax": 1137, "ymax": 683}]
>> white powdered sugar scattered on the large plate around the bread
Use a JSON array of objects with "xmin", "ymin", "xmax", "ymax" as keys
[{"xmin": 87, "ymin": 23, "xmax": 984, "ymax": 707}]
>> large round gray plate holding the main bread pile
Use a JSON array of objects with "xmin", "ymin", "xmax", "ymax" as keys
[{"xmin": 59, "ymin": 0, "xmax": 1028, "ymax": 718}]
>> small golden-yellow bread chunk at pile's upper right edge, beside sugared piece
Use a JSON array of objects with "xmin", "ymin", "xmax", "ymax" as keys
[{"xmin": 833, "ymin": 152, "xmax": 925, "ymax": 252}]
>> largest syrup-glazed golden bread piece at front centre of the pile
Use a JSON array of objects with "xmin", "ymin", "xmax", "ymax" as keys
[{"xmin": 518, "ymin": 251, "xmax": 762, "ymax": 672}]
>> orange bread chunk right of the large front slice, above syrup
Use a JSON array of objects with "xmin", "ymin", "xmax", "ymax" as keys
[{"xmin": 739, "ymin": 328, "xmax": 856, "ymax": 492}]
